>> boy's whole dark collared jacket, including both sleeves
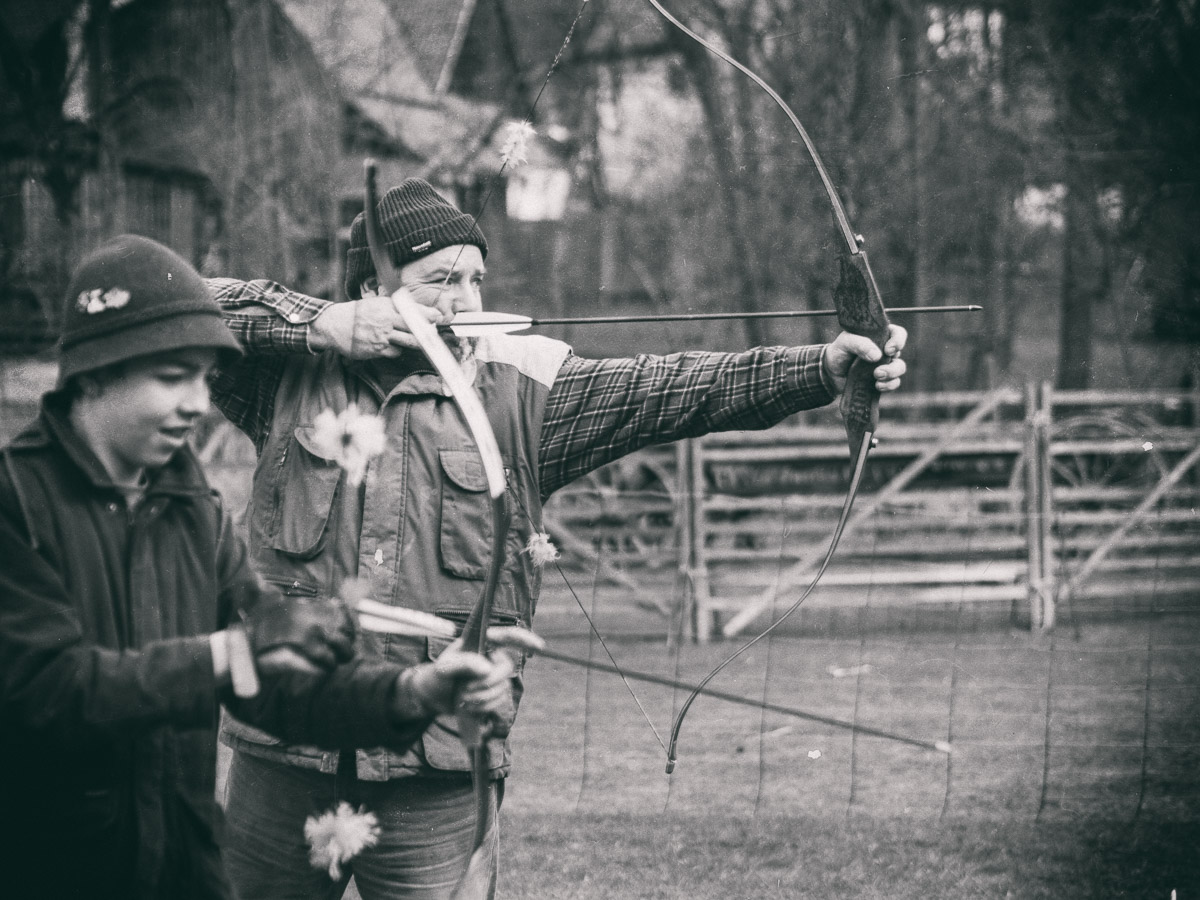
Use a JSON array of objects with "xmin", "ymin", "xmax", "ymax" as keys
[{"xmin": 0, "ymin": 395, "xmax": 428, "ymax": 898}]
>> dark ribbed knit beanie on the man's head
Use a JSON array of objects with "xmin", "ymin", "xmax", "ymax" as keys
[{"xmin": 346, "ymin": 178, "xmax": 487, "ymax": 300}]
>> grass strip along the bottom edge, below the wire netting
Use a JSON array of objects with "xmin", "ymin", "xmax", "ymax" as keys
[{"xmin": 499, "ymin": 816, "xmax": 1200, "ymax": 900}]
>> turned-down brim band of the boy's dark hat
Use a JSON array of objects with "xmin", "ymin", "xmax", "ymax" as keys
[{"xmin": 59, "ymin": 312, "xmax": 241, "ymax": 388}]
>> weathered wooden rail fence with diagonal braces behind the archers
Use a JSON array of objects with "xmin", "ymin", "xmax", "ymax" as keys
[{"xmin": 547, "ymin": 385, "xmax": 1200, "ymax": 641}]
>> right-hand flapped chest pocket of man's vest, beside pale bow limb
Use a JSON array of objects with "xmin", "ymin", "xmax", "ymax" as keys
[{"xmin": 438, "ymin": 450, "xmax": 492, "ymax": 581}]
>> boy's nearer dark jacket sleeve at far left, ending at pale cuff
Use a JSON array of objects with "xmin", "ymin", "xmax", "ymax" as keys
[{"xmin": 0, "ymin": 503, "xmax": 216, "ymax": 744}]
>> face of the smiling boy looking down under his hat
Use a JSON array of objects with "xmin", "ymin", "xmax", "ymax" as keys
[{"xmin": 88, "ymin": 347, "xmax": 217, "ymax": 482}]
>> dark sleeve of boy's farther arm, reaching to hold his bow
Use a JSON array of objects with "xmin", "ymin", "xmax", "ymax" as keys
[{"xmin": 217, "ymin": 501, "xmax": 433, "ymax": 752}]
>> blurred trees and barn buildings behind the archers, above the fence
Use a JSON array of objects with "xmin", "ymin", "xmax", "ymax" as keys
[{"xmin": 0, "ymin": 0, "xmax": 1200, "ymax": 390}]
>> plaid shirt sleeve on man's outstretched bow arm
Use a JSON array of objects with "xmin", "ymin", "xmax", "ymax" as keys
[{"xmin": 539, "ymin": 346, "xmax": 834, "ymax": 499}]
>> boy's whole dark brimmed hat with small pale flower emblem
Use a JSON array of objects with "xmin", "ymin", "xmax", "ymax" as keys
[{"xmin": 59, "ymin": 234, "xmax": 241, "ymax": 386}]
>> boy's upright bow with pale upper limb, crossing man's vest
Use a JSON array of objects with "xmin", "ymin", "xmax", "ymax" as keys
[{"xmin": 364, "ymin": 161, "xmax": 509, "ymax": 899}]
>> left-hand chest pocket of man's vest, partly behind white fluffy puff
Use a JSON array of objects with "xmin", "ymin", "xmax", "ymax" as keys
[{"xmin": 268, "ymin": 425, "xmax": 342, "ymax": 559}]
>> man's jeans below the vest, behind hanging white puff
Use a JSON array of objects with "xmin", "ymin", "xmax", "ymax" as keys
[{"xmin": 224, "ymin": 750, "xmax": 504, "ymax": 900}]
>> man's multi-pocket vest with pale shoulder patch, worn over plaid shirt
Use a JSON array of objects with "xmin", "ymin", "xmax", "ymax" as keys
[{"xmin": 222, "ymin": 336, "xmax": 569, "ymax": 781}]
